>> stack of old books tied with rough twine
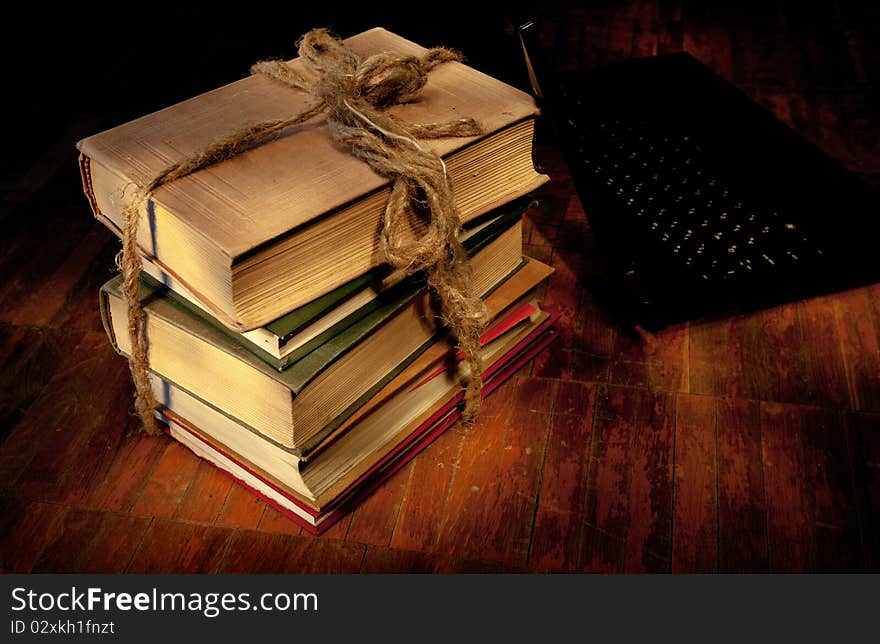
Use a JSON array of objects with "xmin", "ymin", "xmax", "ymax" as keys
[{"xmin": 79, "ymin": 29, "xmax": 553, "ymax": 533}]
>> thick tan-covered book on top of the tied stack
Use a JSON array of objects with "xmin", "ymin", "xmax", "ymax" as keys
[{"xmin": 78, "ymin": 29, "xmax": 547, "ymax": 331}]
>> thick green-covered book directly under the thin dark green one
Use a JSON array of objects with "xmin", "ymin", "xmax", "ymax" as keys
[{"xmin": 101, "ymin": 224, "xmax": 536, "ymax": 449}]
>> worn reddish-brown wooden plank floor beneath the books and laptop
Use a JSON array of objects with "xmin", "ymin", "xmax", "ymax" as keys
[{"xmin": 0, "ymin": 0, "xmax": 880, "ymax": 572}]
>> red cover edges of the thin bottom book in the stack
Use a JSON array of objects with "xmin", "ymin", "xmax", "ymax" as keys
[{"xmin": 165, "ymin": 309, "xmax": 559, "ymax": 536}]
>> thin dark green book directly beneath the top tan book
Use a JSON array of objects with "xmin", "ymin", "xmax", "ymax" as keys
[{"xmin": 144, "ymin": 198, "xmax": 534, "ymax": 370}]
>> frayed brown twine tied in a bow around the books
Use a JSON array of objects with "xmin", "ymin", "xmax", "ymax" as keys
[{"xmin": 119, "ymin": 29, "xmax": 489, "ymax": 433}]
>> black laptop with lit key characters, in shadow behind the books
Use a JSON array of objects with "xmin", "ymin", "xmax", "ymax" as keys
[{"xmin": 512, "ymin": 23, "xmax": 880, "ymax": 328}]
